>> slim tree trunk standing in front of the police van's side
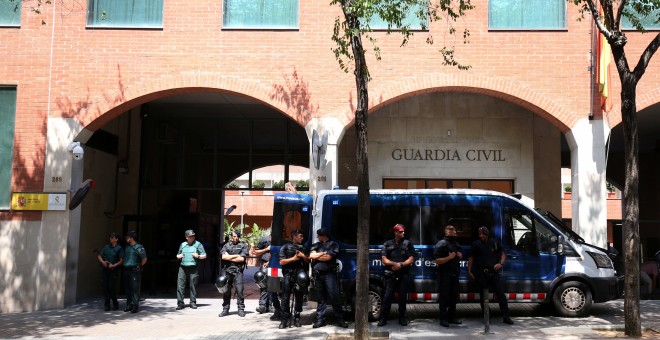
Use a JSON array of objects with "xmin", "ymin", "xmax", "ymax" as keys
[{"xmin": 347, "ymin": 11, "xmax": 371, "ymax": 339}]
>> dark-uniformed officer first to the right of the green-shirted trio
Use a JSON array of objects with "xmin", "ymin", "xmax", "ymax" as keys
[{"xmin": 218, "ymin": 230, "xmax": 247, "ymax": 317}]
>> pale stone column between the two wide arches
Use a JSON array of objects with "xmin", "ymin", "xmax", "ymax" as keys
[{"xmin": 305, "ymin": 118, "xmax": 345, "ymax": 197}]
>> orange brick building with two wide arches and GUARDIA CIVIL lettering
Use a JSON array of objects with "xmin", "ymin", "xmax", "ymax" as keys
[{"xmin": 0, "ymin": 0, "xmax": 660, "ymax": 312}]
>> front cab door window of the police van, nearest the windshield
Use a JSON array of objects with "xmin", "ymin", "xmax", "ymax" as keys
[{"xmin": 504, "ymin": 209, "xmax": 558, "ymax": 255}]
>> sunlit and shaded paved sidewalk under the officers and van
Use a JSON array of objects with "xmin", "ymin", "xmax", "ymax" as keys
[{"xmin": 0, "ymin": 275, "xmax": 660, "ymax": 340}]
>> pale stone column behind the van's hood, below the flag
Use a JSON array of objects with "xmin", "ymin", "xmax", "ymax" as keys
[{"xmin": 566, "ymin": 119, "xmax": 610, "ymax": 248}]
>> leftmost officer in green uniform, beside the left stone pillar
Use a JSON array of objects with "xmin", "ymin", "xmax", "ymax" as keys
[{"xmin": 97, "ymin": 233, "xmax": 124, "ymax": 312}]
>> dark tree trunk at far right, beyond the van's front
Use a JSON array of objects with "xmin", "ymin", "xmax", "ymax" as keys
[{"xmin": 612, "ymin": 54, "xmax": 642, "ymax": 337}]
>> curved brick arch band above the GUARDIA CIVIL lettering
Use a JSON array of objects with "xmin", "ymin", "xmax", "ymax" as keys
[{"xmin": 343, "ymin": 74, "xmax": 581, "ymax": 133}]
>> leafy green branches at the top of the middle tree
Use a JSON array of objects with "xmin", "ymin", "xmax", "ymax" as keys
[{"xmin": 330, "ymin": 0, "xmax": 474, "ymax": 80}]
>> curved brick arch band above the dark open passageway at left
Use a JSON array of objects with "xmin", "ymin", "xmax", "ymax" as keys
[{"xmin": 75, "ymin": 72, "xmax": 312, "ymax": 132}]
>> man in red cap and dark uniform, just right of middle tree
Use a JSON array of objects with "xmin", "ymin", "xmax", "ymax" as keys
[{"xmin": 378, "ymin": 224, "xmax": 415, "ymax": 327}]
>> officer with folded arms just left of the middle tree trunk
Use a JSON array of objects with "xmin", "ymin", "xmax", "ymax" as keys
[{"xmin": 309, "ymin": 228, "xmax": 348, "ymax": 328}]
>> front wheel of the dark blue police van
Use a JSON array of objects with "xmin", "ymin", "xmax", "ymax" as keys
[{"xmin": 552, "ymin": 281, "xmax": 593, "ymax": 317}]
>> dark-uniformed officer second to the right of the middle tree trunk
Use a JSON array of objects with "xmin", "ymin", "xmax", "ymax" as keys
[{"xmin": 433, "ymin": 224, "xmax": 463, "ymax": 327}]
